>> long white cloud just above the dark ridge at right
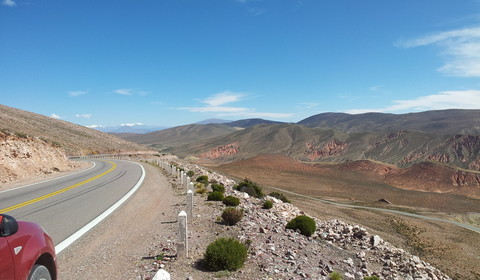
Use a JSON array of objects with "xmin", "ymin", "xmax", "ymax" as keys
[{"xmin": 346, "ymin": 90, "xmax": 480, "ymax": 114}]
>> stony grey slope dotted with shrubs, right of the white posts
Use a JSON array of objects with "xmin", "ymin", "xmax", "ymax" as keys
[{"xmin": 140, "ymin": 158, "xmax": 451, "ymax": 280}]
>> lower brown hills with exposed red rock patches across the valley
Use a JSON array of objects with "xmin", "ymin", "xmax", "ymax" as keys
[{"xmin": 172, "ymin": 124, "xmax": 480, "ymax": 170}]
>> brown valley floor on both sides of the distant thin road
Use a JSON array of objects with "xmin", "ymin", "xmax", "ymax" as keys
[{"xmin": 210, "ymin": 156, "xmax": 480, "ymax": 279}]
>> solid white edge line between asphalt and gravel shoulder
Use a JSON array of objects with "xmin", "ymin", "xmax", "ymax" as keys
[{"xmin": 55, "ymin": 162, "xmax": 145, "ymax": 254}]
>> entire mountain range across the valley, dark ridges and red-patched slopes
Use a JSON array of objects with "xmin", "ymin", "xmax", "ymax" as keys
[{"xmin": 115, "ymin": 110, "xmax": 480, "ymax": 170}]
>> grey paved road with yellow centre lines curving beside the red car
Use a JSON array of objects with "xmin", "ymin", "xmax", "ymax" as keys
[{"xmin": 0, "ymin": 160, "xmax": 143, "ymax": 245}]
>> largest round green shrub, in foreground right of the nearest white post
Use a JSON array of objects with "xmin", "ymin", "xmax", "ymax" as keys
[{"xmin": 203, "ymin": 238, "xmax": 247, "ymax": 271}]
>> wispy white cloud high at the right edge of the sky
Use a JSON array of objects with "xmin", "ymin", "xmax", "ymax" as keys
[{"xmin": 398, "ymin": 26, "xmax": 480, "ymax": 77}]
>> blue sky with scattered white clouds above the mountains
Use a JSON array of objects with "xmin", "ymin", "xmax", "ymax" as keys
[{"xmin": 0, "ymin": 0, "xmax": 480, "ymax": 126}]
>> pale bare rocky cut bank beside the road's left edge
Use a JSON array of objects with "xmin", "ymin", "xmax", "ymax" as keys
[{"xmin": 0, "ymin": 132, "xmax": 79, "ymax": 184}]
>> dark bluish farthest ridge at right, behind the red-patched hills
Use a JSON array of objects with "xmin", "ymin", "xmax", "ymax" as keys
[{"xmin": 298, "ymin": 109, "xmax": 480, "ymax": 135}]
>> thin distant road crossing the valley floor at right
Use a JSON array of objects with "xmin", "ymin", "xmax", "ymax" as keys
[{"xmin": 271, "ymin": 187, "xmax": 480, "ymax": 233}]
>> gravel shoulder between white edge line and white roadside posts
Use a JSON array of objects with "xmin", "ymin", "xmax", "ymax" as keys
[{"xmin": 58, "ymin": 163, "xmax": 178, "ymax": 279}]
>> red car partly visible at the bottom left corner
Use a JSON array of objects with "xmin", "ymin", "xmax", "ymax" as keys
[{"xmin": 0, "ymin": 214, "xmax": 57, "ymax": 280}]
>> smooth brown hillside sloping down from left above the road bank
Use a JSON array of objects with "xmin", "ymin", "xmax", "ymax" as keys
[{"xmin": 0, "ymin": 105, "xmax": 148, "ymax": 155}]
